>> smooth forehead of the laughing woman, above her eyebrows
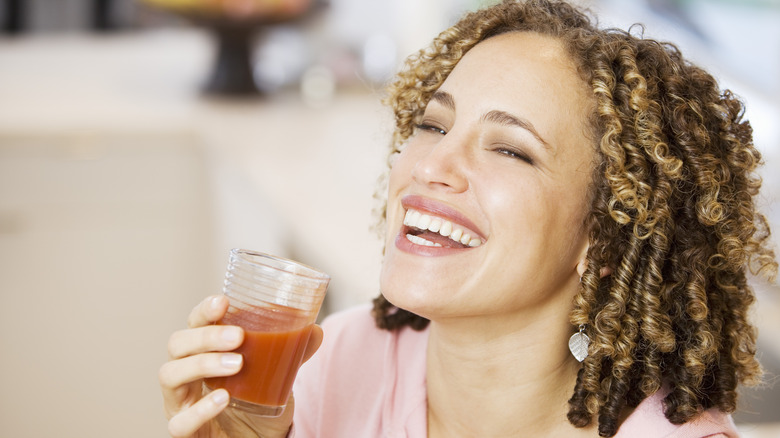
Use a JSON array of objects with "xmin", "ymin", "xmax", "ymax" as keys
[{"xmin": 436, "ymin": 32, "xmax": 594, "ymax": 151}]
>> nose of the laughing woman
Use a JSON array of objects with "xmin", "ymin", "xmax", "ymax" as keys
[{"xmin": 412, "ymin": 133, "xmax": 469, "ymax": 193}]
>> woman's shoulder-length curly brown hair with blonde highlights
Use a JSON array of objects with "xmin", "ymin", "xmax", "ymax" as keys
[{"xmin": 374, "ymin": 0, "xmax": 777, "ymax": 436}]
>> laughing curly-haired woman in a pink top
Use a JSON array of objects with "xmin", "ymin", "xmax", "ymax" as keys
[{"xmin": 160, "ymin": 0, "xmax": 777, "ymax": 437}]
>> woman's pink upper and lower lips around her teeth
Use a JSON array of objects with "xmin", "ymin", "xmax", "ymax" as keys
[{"xmin": 395, "ymin": 195, "xmax": 486, "ymax": 256}]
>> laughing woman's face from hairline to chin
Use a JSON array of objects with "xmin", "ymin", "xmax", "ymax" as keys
[{"xmin": 381, "ymin": 33, "xmax": 595, "ymax": 320}]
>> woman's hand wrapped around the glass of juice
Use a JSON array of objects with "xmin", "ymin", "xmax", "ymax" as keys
[{"xmin": 159, "ymin": 295, "xmax": 322, "ymax": 438}]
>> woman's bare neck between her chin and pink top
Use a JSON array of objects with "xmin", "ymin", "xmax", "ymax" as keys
[{"xmin": 427, "ymin": 315, "xmax": 592, "ymax": 437}]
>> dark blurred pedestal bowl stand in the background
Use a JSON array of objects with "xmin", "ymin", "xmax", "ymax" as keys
[{"xmin": 139, "ymin": 0, "xmax": 322, "ymax": 96}]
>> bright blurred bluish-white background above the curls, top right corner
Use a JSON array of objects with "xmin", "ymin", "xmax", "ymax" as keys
[{"xmin": 590, "ymin": 0, "xmax": 780, "ymax": 161}]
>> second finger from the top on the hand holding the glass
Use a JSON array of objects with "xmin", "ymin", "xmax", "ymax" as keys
[{"xmin": 168, "ymin": 325, "xmax": 244, "ymax": 359}]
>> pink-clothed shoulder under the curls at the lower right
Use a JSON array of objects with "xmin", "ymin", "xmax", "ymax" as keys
[{"xmin": 616, "ymin": 390, "xmax": 739, "ymax": 438}]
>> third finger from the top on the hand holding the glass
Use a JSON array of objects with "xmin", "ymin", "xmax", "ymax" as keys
[{"xmin": 159, "ymin": 353, "xmax": 243, "ymax": 396}]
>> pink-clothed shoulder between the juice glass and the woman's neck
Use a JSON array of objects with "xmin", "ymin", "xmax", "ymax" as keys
[{"xmin": 294, "ymin": 305, "xmax": 427, "ymax": 437}]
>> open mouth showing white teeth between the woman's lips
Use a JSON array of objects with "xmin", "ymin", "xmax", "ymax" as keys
[{"xmin": 402, "ymin": 209, "xmax": 483, "ymax": 248}]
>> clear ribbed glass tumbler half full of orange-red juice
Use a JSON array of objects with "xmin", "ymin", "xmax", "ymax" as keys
[{"xmin": 205, "ymin": 249, "xmax": 330, "ymax": 417}]
